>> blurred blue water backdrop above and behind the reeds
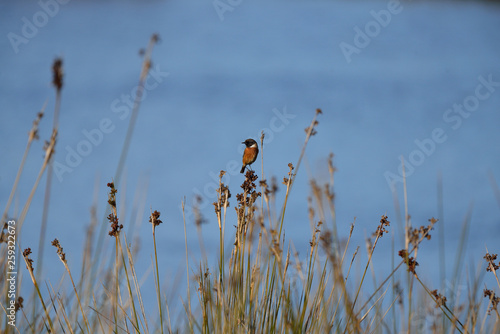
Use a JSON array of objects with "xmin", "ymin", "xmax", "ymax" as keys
[{"xmin": 0, "ymin": 0, "xmax": 500, "ymax": 324}]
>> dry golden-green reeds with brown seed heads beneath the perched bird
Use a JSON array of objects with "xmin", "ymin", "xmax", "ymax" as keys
[{"xmin": 0, "ymin": 35, "xmax": 500, "ymax": 333}]
